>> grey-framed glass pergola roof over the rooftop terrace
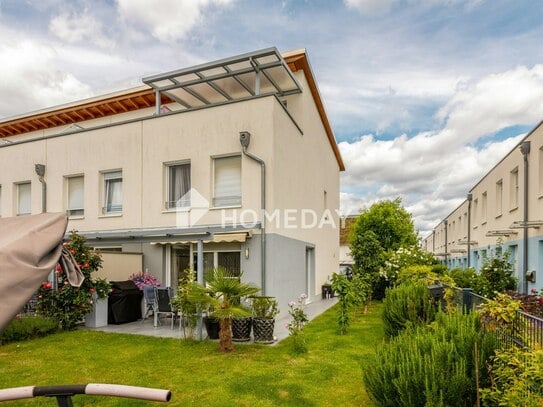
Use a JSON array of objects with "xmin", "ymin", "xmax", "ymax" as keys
[{"xmin": 143, "ymin": 47, "xmax": 302, "ymax": 110}]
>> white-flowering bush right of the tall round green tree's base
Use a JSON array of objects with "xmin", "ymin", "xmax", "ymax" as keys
[{"xmin": 379, "ymin": 246, "xmax": 436, "ymax": 284}]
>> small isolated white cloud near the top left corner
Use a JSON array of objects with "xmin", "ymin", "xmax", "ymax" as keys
[{"xmin": 49, "ymin": 10, "xmax": 114, "ymax": 48}]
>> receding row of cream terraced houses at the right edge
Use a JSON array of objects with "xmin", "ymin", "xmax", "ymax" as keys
[{"xmin": 422, "ymin": 119, "xmax": 543, "ymax": 292}]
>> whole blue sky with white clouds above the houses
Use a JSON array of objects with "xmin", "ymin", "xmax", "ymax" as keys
[{"xmin": 0, "ymin": 0, "xmax": 543, "ymax": 237}]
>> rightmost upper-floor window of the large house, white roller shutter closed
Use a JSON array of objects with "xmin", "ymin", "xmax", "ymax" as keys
[{"xmin": 213, "ymin": 155, "xmax": 241, "ymax": 207}]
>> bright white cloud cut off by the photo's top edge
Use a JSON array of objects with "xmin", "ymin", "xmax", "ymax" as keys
[{"xmin": 117, "ymin": 0, "xmax": 234, "ymax": 42}]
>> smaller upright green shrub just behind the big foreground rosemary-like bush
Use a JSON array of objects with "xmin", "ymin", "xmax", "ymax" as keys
[{"xmin": 383, "ymin": 282, "xmax": 436, "ymax": 337}]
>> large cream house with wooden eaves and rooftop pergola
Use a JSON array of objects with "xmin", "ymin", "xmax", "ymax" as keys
[{"xmin": 0, "ymin": 48, "xmax": 344, "ymax": 309}]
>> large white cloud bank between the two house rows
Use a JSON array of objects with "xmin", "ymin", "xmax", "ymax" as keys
[{"xmin": 339, "ymin": 65, "xmax": 543, "ymax": 233}]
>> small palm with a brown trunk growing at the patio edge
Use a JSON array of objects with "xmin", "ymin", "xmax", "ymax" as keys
[{"xmin": 191, "ymin": 268, "xmax": 260, "ymax": 352}]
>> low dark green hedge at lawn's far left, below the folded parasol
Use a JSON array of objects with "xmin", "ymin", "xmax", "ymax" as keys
[{"xmin": 0, "ymin": 316, "xmax": 58, "ymax": 345}]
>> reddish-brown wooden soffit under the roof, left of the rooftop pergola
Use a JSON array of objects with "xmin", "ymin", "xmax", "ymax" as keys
[{"xmin": 0, "ymin": 89, "xmax": 171, "ymax": 138}]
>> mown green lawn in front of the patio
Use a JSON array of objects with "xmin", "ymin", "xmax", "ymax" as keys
[{"xmin": 0, "ymin": 304, "xmax": 383, "ymax": 407}]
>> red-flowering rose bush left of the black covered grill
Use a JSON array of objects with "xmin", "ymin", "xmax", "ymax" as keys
[{"xmin": 37, "ymin": 231, "xmax": 107, "ymax": 330}]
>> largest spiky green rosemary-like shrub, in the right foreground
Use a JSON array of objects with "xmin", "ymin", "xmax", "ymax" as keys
[{"xmin": 363, "ymin": 312, "xmax": 496, "ymax": 407}]
